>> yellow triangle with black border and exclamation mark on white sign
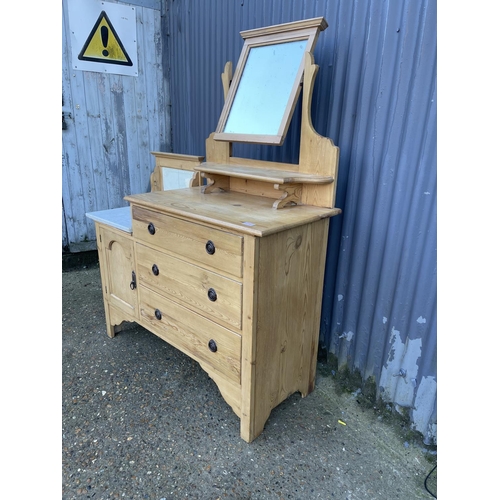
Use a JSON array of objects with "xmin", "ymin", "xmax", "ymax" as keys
[{"xmin": 78, "ymin": 11, "xmax": 132, "ymax": 66}]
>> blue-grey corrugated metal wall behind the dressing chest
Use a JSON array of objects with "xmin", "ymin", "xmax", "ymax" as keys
[{"xmin": 164, "ymin": 0, "xmax": 437, "ymax": 444}]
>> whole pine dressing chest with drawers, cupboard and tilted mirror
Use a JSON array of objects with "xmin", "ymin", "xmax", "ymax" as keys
[{"xmin": 87, "ymin": 18, "xmax": 340, "ymax": 442}]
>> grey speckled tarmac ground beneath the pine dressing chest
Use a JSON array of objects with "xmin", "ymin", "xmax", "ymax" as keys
[{"xmin": 62, "ymin": 264, "xmax": 437, "ymax": 500}]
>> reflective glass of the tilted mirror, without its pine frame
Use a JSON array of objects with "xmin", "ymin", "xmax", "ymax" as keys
[{"xmin": 223, "ymin": 39, "xmax": 308, "ymax": 135}]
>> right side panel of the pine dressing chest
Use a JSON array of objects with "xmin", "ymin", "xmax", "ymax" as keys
[{"xmin": 249, "ymin": 220, "xmax": 329, "ymax": 438}]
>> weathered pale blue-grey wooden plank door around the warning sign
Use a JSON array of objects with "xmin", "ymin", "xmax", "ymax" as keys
[{"xmin": 62, "ymin": 1, "xmax": 170, "ymax": 249}]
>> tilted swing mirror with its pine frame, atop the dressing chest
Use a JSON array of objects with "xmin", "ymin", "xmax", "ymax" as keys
[{"xmin": 214, "ymin": 17, "xmax": 328, "ymax": 145}]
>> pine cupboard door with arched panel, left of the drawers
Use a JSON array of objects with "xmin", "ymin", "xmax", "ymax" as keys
[{"xmin": 100, "ymin": 227, "xmax": 138, "ymax": 318}]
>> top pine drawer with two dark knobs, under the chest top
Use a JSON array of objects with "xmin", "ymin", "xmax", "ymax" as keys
[{"xmin": 132, "ymin": 205, "xmax": 243, "ymax": 277}]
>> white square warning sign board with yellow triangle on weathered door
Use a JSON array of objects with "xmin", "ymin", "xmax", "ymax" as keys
[{"xmin": 68, "ymin": 0, "xmax": 138, "ymax": 76}]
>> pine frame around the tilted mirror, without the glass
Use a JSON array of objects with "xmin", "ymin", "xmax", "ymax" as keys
[{"xmin": 213, "ymin": 17, "xmax": 328, "ymax": 145}]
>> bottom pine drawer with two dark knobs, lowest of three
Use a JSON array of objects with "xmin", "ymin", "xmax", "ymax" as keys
[{"xmin": 139, "ymin": 286, "xmax": 241, "ymax": 384}]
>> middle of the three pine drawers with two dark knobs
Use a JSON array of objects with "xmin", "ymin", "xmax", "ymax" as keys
[{"xmin": 136, "ymin": 243, "xmax": 243, "ymax": 329}]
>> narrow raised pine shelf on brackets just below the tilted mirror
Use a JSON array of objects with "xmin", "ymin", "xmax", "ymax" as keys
[{"xmin": 194, "ymin": 163, "xmax": 333, "ymax": 184}]
